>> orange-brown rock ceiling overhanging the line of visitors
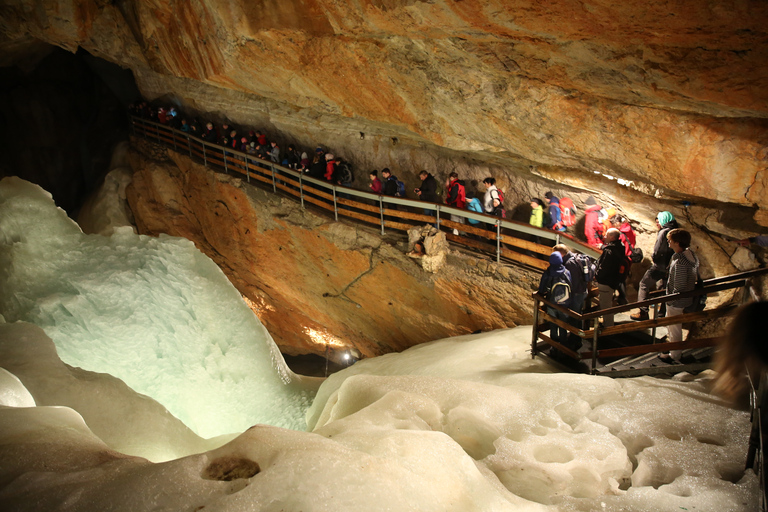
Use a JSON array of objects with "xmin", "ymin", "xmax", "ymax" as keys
[{"xmin": 0, "ymin": 0, "xmax": 768, "ymax": 234}]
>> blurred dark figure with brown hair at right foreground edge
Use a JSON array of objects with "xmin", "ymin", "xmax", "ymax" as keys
[{"xmin": 715, "ymin": 302, "xmax": 768, "ymax": 511}]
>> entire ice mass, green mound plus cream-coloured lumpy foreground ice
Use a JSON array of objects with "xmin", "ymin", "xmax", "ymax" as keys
[{"xmin": 0, "ymin": 175, "xmax": 757, "ymax": 512}]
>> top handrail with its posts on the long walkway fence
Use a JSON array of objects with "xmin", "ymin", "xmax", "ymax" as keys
[{"xmin": 130, "ymin": 116, "xmax": 601, "ymax": 261}]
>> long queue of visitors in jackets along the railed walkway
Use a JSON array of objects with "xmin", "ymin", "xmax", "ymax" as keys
[{"xmin": 131, "ymin": 102, "xmax": 724, "ymax": 362}]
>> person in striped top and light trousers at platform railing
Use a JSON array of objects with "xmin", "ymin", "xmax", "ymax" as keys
[{"xmin": 659, "ymin": 228, "xmax": 699, "ymax": 364}]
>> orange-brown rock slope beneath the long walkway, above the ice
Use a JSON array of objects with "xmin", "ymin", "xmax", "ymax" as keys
[{"xmin": 127, "ymin": 140, "xmax": 538, "ymax": 356}]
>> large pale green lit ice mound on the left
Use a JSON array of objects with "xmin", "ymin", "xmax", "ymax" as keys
[{"xmin": 0, "ymin": 178, "xmax": 316, "ymax": 437}]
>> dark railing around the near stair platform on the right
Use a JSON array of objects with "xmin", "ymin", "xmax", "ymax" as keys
[{"xmin": 531, "ymin": 268, "xmax": 768, "ymax": 373}]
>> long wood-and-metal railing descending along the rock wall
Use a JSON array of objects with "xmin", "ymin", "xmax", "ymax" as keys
[{"xmin": 130, "ymin": 116, "xmax": 601, "ymax": 270}]
